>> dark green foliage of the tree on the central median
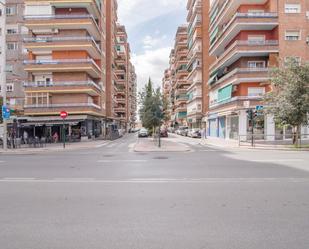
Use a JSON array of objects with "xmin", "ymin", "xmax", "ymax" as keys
[{"xmin": 139, "ymin": 79, "xmax": 164, "ymax": 130}]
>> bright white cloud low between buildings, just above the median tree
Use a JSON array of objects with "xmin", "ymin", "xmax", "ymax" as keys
[{"xmin": 132, "ymin": 47, "xmax": 171, "ymax": 90}]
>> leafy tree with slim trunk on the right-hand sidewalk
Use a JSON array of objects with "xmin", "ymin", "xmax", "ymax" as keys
[{"xmin": 265, "ymin": 59, "xmax": 309, "ymax": 145}]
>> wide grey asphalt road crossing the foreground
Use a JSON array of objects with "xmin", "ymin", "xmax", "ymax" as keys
[{"xmin": 0, "ymin": 135, "xmax": 309, "ymax": 249}]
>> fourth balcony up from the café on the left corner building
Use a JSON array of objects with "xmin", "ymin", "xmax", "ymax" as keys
[{"xmin": 23, "ymin": 36, "xmax": 102, "ymax": 59}]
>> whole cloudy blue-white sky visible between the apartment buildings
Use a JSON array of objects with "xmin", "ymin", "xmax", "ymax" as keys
[{"xmin": 118, "ymin": 0, "xmax": 187, "ymax": 91}]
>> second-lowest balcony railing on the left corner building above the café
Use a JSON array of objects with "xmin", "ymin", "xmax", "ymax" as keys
[{"xmin": 24, "ymin": 81, "xmax": 102, "ymax": 90}]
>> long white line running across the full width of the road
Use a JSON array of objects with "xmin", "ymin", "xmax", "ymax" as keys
[{"xmin": 0, "ymin": 178, "xmax": 309, "ymax": 184}]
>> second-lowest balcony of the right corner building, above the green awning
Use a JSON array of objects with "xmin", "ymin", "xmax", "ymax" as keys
[{"xmin": 208, "ymin": 68, "xmax": 269, "ymax": 88}]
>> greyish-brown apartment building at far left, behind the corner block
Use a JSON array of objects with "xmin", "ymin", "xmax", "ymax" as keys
[{"xmin": 1, "ymin": 0, "xmax": 28, "ymax": 116}]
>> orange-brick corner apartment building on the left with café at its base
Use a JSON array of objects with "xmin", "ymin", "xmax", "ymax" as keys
[{"xmin": 24, "ymin": 0, "xmax": 106, "ymax": 139}]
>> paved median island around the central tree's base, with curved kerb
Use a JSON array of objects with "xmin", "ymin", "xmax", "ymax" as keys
[{"xmin": 134, "ymin": 138, "xmax": 190, "ymax": 152}]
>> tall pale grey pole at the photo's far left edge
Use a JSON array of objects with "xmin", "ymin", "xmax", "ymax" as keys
[{"xmin": 0, "ymin": 0, "xmax": 8, "ymax": 150}]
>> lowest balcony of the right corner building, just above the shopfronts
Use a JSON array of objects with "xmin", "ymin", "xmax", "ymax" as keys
[{"xmin": 209, "ymin": 96, "xmax": 263, "ymax": 110}]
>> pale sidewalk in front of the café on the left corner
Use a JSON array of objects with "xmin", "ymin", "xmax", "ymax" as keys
[{"xmin": 0, "ymin": 140, "xmax": 110, "ymax": 154}]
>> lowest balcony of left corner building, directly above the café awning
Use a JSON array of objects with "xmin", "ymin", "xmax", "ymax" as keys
[{"xmin": 24, "ymin": 103, "xmax": 102, "ymax": 116}]
